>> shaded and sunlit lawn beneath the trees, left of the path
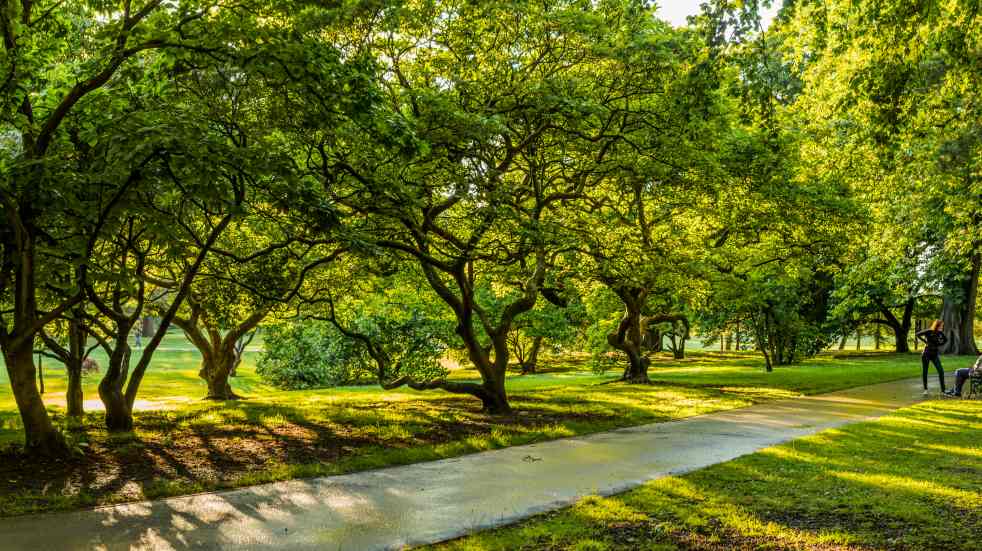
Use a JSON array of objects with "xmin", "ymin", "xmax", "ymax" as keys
[{"xmin": 0, "ymin": 340, "xmax": 936, "ymax": 515}]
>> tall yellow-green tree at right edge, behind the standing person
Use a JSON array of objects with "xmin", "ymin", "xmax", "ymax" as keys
[{"xmin": 785, "ymin": 1, "xmax": 982, "ymax": 354}]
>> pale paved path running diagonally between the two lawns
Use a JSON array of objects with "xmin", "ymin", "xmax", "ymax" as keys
[{"xmin": 0, "ymin": 379, "xmax": 921, "ymax": 551}]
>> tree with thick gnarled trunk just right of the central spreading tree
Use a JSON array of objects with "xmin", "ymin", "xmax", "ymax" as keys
[{"xmin": 568, "ymin": 17, "xmax": 731, "ymax": 383}]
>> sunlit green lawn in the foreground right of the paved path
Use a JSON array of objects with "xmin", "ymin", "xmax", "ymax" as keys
[{"xmin": 432, "ymin": 400, "xmax": 982, "ymax": 551}]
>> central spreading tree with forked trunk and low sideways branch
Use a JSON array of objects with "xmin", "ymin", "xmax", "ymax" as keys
[{"xmin": 314, "ymin": 2, "xmax": 676, "ymax": 413}]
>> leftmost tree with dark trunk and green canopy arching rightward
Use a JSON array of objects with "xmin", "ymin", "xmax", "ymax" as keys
[{"xmin": 0, "ymin": 0, "xmax": 384, "ymax": 454}]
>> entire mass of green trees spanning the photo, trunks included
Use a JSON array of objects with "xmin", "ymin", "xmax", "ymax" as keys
[{"xmin": 0, "ymin": 0, "xmax": 982, "ymax": 454}]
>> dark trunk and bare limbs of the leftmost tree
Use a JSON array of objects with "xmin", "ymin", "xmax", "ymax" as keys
[{"xmin": 0, "ymin": 0, "xmax": 226, "ymax": 455}]
